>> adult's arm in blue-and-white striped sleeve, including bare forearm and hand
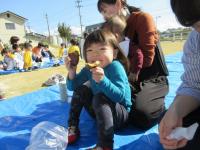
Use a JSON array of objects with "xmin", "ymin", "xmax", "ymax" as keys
[{"xmin": 159, "ymin": 32, "xmax": 200, "ymax": 149}]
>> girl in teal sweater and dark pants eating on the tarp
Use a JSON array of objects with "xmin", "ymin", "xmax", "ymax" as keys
[{"xmin": 65, "ymin": 30, "xmax": 132, "ymax": 150}]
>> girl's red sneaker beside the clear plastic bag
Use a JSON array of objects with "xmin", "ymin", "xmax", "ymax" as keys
[{"xmin": 68, "ymin": 126, "xmax": 80, "ymax": 144}]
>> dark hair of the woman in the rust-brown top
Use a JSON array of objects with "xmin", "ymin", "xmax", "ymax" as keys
[{"xmin": 97, "ymin": 0, "xmax": 141, "ymax": 13}]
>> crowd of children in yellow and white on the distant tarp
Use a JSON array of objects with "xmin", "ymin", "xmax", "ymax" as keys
[{"xmin": 0, "ymin": 36, "xmax": 80, "ymax": 71}]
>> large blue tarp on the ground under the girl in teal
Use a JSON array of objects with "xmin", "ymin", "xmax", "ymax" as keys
[{"xmin": 0, "ymin": 52, "xmax": 183, "ymax": 150}]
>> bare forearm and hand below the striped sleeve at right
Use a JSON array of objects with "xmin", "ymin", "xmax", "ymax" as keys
[{"xmin": 159, "ymin": 95, "xmax": 200, "ymax": 149}]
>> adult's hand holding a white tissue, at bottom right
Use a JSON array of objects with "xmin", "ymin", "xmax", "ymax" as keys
[{"xmin": 159, "ymin": 105, "xmax": 187, "ymax": 149}]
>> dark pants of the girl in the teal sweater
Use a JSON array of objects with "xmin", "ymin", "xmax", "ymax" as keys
[{"xmin": 68, "ymin": 85, "xmax": 128, "ymax": 148}]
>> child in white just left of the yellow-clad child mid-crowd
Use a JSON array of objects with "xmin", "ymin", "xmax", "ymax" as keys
[{"xmin": 12, "ymin": 44, "xmax": 24, "ymax": 70}]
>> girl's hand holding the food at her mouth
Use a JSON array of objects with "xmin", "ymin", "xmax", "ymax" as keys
[{"xmin": 90, "ymin": 67, "xmax": 104, "ymax": 83}]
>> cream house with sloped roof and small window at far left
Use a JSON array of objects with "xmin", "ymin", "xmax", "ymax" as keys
[{"xmin": 0, "ymin": 11, "xmax": 27, "ymax": 44}]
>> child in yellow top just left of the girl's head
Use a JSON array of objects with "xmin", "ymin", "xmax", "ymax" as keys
[{"xmin": 68, "ymin": 39, "xmax": 80, "ymax": 66}]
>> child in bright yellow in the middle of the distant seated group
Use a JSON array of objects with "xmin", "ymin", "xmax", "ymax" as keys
[{"xmin": 24, "ymin": 43, "xmax": 33, "ymax": 71}]
